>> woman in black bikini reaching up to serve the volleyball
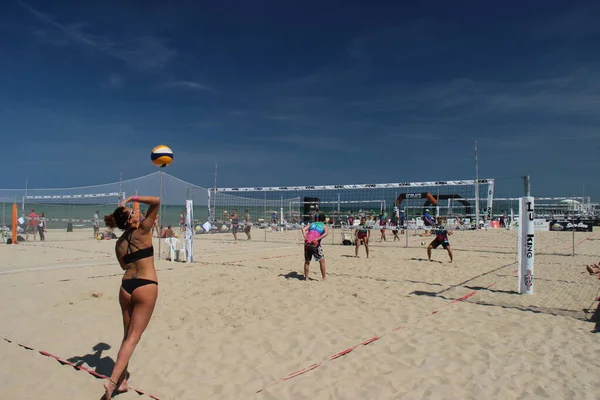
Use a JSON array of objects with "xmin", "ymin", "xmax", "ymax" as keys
[{"xmin": 103, "ymin": 196, "xmax": 160, "ymax": 400}]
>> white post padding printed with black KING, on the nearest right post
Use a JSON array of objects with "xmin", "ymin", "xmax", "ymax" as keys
[{"xmin": 518, "ymin": 197, "xmax": 535, "ymax": 294}]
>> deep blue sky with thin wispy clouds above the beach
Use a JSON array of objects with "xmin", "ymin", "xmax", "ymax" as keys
[{"xmin": 0, "ymin": 0, "xmax": 600, "ymax": 199}]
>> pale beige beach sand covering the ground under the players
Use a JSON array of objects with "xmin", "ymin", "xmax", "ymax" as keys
[{"xmin": 0, "ymin": 229, "xmax": 600, "ymax": 400}]
